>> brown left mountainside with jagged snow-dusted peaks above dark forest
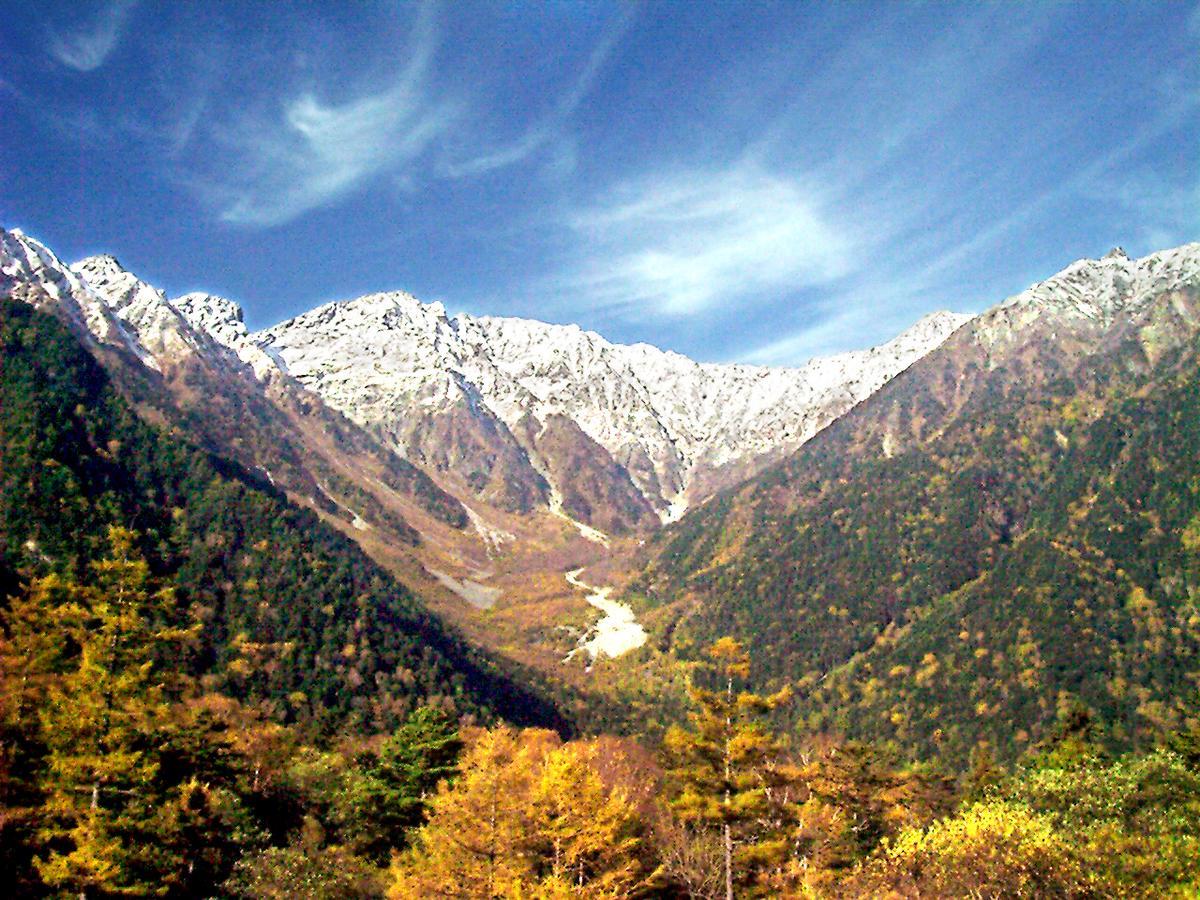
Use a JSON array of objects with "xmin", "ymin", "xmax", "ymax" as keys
[{"xmin": 0, "ymin": 232, "xmax": 480, "ymax": 571}]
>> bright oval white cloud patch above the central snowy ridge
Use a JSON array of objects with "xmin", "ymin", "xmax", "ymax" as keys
[{"xmin": 560, "ymin": 166, "xmax": 853, "ymax": 317}]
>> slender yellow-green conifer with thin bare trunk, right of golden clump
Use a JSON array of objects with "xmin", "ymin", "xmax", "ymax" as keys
[{"xmin": 664, "ymin": 637, "xmax": 792, "ymax": 900}]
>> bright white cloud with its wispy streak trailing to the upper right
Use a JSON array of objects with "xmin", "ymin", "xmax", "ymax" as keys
[{"xmin": 525, "ymin": 7, "xmax": 1056, "ymax": 340}]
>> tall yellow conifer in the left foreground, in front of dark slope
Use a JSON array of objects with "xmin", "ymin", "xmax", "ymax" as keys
[{"xmin": 19, "ymin": 528, "xmax": 198, "ymax": 898}]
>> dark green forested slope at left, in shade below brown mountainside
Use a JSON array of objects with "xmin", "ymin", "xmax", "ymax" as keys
[{"xmin": 0, "ymin": 299, "xmax": 563, "ymax": 728}]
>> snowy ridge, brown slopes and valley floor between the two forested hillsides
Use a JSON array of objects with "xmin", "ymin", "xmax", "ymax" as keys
[{"xmin": 2, "ymin": 226, "xmax": 965, "ymax": 686}]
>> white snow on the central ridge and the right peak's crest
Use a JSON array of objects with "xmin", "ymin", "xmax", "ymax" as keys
[{"xmin": 252, "ymin": 244, "xmax": 1200, "ymax": 521}]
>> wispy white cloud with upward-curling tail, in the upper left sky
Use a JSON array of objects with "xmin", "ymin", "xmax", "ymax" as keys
[{"xmin": 196, "ymin": 7, "xmax": 457, "ymax": 226}]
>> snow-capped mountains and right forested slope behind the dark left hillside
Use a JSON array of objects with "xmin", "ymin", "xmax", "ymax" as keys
[{"xmin": 0, "ymin": 230, "xmax": 1200, "ymax": 758}]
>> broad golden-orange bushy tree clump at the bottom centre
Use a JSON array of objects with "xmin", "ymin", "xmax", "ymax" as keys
[{"xmin": 388, "ymin": 727, "xmax": 648, "ymax": 900}]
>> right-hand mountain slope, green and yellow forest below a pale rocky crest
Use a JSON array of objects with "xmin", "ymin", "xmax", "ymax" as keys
[{"xmin": 636, "ymin": 245, "xmax": 1200, "ymax": 755}]
